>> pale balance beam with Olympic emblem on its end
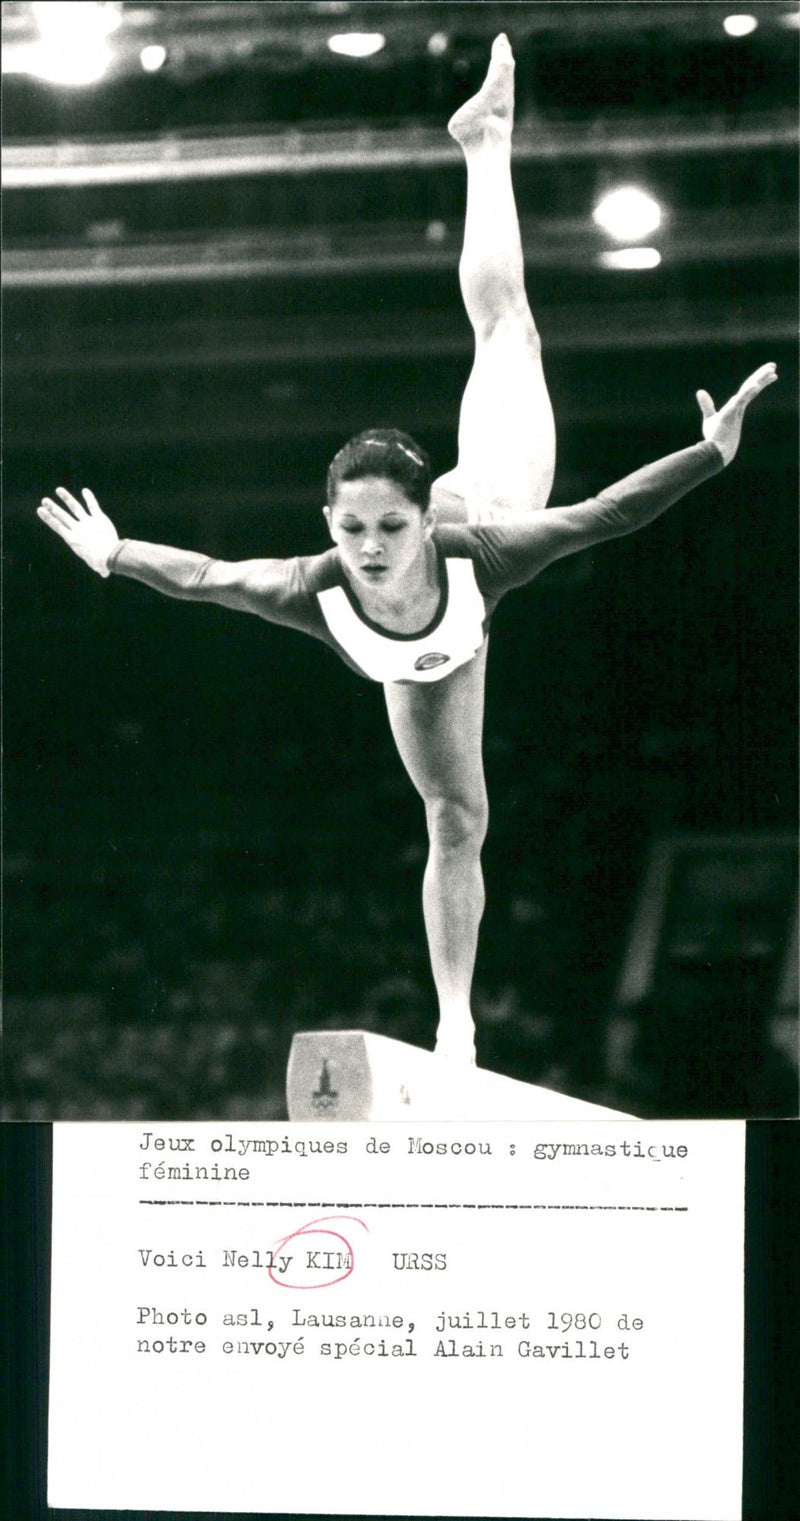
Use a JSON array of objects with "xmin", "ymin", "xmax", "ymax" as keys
[{"xmin": 286, "ymin": 1030, "xmax": 631, "ymax": 1119}]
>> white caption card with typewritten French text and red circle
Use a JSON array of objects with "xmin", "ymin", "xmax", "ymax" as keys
[{"xmin": 49, "ymin": 1121, "xmax": 745, "ymax": 1521}]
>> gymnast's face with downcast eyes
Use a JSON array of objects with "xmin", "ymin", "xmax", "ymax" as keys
[{"xmin": 325, "ymin": 476, "xmax": 435, "ymax": 593}]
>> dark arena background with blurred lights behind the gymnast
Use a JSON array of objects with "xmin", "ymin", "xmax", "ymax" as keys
[{"xmin": 3, "ymin": 0, "xmax": 798, "ymax": 1119}]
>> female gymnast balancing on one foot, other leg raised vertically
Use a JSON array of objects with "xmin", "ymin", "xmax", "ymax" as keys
[{"xmin": 38, "ymin": 35, "xmax": 777, "ymax": 1062}]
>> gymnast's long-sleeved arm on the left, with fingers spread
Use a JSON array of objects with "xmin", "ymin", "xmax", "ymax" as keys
[{"xmin": 37, "ymin": 485, "xmax": 284, "ymax": 616}]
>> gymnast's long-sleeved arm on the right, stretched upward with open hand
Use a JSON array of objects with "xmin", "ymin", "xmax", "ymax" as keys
[{"xmin": 485, "ymin": 364, "xmax": 777, "ymax": 586}]
